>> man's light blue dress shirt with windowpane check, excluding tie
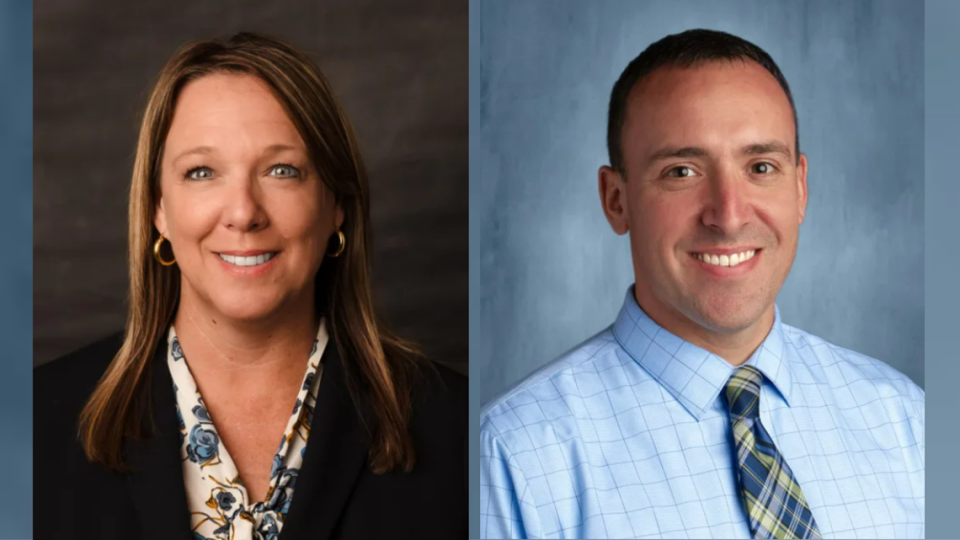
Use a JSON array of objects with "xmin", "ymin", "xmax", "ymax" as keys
[{"xmin": 480, "ymin": 287, "xmax": 924, "ymax": 538}]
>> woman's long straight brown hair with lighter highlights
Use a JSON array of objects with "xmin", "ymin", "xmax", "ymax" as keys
[{"xmin": 79, "ymin": 33, "xmax": 419, "ymax": 473}]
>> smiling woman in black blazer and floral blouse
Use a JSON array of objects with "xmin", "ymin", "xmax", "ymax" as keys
[{"xmin": 34, "ymin": 34, "xmax": 467, "ymax": 540}]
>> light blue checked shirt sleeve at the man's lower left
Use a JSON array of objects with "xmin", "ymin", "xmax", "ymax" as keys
[{"xmin": 480, "ymin": 426, "xmax": 540, "ymax": 538}]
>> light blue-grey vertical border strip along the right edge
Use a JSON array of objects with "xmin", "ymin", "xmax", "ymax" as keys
[{"xmin": 924, "ymin": 0, "xmax": 960, "ymax": 538}]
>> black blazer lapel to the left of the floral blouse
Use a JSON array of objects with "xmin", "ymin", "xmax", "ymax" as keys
[{"xmin": 125, "ymin": 342, "xmax": 192, "ymax": 540}]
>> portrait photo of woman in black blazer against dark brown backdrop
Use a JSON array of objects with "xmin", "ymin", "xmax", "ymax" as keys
[{"xmin": 33, "ymin": 0, "xmax": 468, "ymax": 540}]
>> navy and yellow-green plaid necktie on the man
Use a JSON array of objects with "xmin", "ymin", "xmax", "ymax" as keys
[{"xmin": 723, "ymin": 366, "xmax": 820, "ymax": 538}]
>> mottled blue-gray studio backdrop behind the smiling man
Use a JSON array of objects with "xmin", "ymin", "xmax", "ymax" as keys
[{"xmin": 470, "ymin": 0, "xmax": 924, "ymax": 403}]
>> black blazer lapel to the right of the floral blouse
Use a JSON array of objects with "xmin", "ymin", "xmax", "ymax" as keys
[{"xmin": 281, "ymin": 339, "xmax": 370, "ymax": 540}]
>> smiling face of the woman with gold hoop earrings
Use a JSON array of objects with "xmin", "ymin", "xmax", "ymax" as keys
[{"xmin": 154, "ymin": 74, "xmax": 343, "ymax": 321}]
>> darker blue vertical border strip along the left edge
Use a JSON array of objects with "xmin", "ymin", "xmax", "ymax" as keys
[{"xmin": 0, "ymin": 0, "xmax": 31, "ymax": 538}]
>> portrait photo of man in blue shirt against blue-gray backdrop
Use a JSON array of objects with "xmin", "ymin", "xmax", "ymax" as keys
[{"xmin": 470, "ymin": 0, "xmax": 929, "ymax": 538}]
